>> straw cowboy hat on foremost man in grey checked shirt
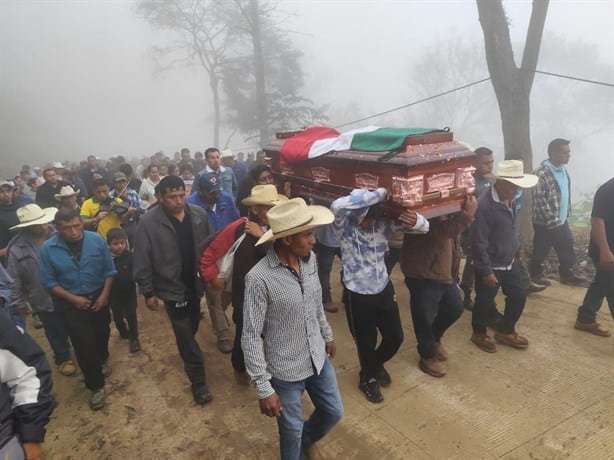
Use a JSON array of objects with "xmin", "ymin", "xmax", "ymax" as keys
[{"xmin": 256, "ymin": 198, "xmax": 335, "ymax": 246}]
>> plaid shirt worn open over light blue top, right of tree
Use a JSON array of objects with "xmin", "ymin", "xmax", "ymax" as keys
[{"xmin": 533, "ymin": 161, "xmax": 571, "ymax": 229}]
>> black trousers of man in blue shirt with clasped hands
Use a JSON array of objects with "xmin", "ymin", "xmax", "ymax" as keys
[{"xmin": 64, "ymin": 304, "xmax": 111, "ymax": 391}]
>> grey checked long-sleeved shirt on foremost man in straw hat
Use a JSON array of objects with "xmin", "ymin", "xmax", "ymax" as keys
[{"xmin": 241, "ymin": 247, "xmax": 333, "ymax": 399}]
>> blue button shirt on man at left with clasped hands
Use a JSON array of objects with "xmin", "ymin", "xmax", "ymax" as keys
[{"xmin": 39, "ymin": 231, "xmax": 117, "ymax": 295}]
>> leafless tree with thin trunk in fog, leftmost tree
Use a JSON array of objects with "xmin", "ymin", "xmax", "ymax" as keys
[{"xmin": 137, "ymin": 0, "xmax": 237, "ymax": 145}]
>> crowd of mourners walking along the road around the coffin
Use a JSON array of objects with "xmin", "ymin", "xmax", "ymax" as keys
[{"xmin": 0, "ymin": 139, "xmax": 614, "ymax": 459}]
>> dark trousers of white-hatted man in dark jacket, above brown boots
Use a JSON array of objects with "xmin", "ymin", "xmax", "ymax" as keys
[{"xmin": 471, "ymin": 261, "xmax": 529, "ymax": 334}]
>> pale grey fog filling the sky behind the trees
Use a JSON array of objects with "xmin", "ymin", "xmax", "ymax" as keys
[{"xmin": 0, "ymin": 0, "xmax": 614, "ymax": 198}]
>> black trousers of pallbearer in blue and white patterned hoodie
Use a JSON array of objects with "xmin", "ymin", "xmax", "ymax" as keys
[{"xmin": 343, "ymin": 281, "xmax": 403, "ymax": 380}]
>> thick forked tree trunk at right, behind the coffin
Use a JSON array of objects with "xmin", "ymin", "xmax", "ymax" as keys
[{"xmin": 477, "ymin": 0, "xmax": 549, "ymax": 245}]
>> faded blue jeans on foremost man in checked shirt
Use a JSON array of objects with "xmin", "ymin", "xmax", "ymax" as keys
[{"xmin": 271, "ymin": 359, "xmax": 343, "ymax": 460}]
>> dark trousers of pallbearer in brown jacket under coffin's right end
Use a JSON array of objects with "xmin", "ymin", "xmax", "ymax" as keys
[{"xmin": 405, "ymin": 278, "xmax": 464, "ymax": 359}]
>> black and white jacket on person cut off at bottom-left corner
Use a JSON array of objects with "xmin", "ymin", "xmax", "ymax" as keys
[{"xmin": 0, "ymin": 307, "xmax": 55, "ymax": 445}]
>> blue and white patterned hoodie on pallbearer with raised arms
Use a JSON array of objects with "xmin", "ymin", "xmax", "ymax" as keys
[{"xmin": 331, "ymin": 188, "xmax": 429, "ymax": 295}]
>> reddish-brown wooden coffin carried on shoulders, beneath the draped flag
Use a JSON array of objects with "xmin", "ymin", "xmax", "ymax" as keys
[{"xmin": 263, "ymin": 128, "xmax": 475, "ymax": 218}]
